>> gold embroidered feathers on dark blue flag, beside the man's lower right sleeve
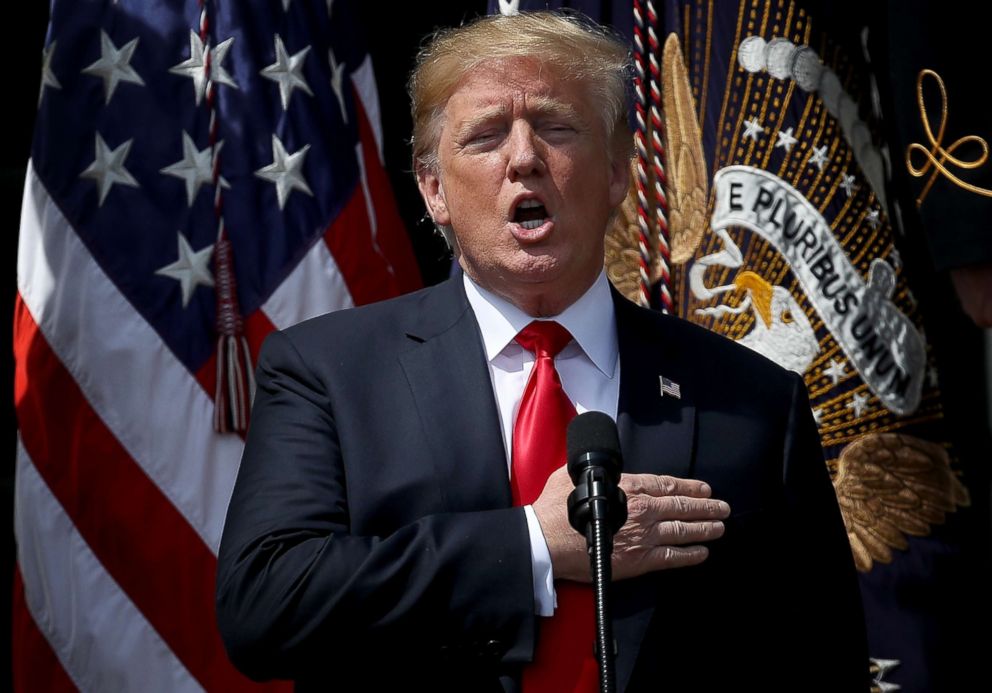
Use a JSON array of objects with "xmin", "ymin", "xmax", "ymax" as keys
[{"xmin": 834, "ymin": 433, "xmax": 970, "ymax": 572}]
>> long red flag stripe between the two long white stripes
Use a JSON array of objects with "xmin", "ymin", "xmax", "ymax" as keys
[{"xmin": 14, "ymin": 295, "xmax": 286, "ymax": 691}]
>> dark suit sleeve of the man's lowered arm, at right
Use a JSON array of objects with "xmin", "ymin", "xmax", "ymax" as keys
[{"xmin": 783, "ymin": 374, "xmax": 870, "ymax": 691}]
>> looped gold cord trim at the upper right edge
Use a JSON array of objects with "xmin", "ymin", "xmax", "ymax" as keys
[{"xmin": 906, "ymin": 70, "xmax": 992, "ymax": 207}]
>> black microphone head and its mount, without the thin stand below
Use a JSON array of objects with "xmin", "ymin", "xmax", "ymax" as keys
[{"xmin": 565, "ymin": 411, "xmax": 627, "ymax": 547}]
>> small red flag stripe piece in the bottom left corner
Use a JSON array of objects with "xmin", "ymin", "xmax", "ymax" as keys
[{"xmin": 11, "ymin": 568, "xmax": 78, "ymax": 693}]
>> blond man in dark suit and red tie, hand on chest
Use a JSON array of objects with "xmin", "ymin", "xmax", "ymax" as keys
[{"xmin": 218, "ymin": 14, "xmax": 867, "ymax": 691}]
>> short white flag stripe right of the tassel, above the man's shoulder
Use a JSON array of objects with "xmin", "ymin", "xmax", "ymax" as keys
[{"xmin": 262, "ymin": 238, "xmax": 355, "ymax": 330}]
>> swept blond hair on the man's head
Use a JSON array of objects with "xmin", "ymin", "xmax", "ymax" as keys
[{"xmin": 407, "ymin": 12, "xmax": 631, "ymax": 173}]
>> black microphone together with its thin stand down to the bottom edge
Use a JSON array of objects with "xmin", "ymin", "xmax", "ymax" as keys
[{"xmin": 565, "ymin": 411, "xmax": 627, "ymax": 693}]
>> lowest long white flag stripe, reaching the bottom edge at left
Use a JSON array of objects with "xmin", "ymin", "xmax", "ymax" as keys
[{"xmin": 14, "ymin": 437, "xmax": 203, "ymax": 693}]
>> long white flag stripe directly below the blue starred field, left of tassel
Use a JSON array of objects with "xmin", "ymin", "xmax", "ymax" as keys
[{"xmin": 17, "ymin": 162, "xmax": 242, "ymax": 554}]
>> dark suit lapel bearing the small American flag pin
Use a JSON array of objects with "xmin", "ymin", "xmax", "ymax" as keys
[{"xmin": 612, "ymin": 291, "xmax": 696, "ymax": 690}]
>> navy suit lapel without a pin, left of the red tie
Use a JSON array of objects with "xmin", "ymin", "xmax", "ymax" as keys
[{"xmin": 400, "ymin": 279, "xmax": 512, "ymax": 512}]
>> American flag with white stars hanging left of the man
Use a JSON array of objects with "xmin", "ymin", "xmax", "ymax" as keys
[{"xmin": 13, "ymin": 0, "xmax": 420, "ymax": 691}]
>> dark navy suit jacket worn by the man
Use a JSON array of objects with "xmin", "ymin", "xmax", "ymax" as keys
[{"xmin": 217, "ymin": 280, "xmax": 867, "ymax": 691}]
